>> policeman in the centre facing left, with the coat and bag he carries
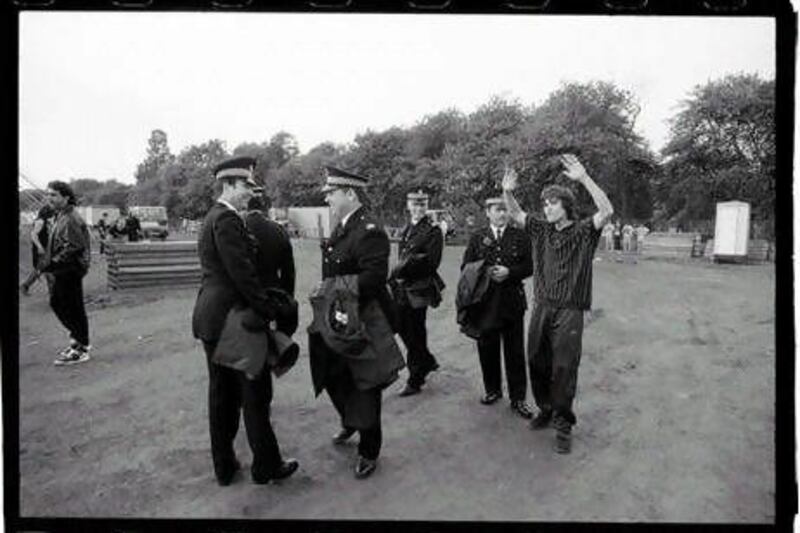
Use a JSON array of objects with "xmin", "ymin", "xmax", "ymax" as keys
[{"xmin": 308, "ymin": 167, "xmax": 405, "ymax": 479}]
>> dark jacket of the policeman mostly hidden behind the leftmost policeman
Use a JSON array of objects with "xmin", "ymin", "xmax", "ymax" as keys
[{"xmin": 244, "ymin": 211, "xmax": 295, "ymax": 296}]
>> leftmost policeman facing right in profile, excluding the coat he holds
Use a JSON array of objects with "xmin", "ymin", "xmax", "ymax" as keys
[{"xmin": 192, "ymin": 157, "xmax": 298, "ymax": 486}]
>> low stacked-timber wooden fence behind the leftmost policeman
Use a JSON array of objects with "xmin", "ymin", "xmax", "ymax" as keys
[{"xmin": 107, "ymin": 241, "xmax": 200, "ymax": 290}]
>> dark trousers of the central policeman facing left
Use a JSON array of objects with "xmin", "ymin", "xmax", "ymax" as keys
[{"xmin": 325, "ymin": 356, "xmax": 383, "ymax": 459}]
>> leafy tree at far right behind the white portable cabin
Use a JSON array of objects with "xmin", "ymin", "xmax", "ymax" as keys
[{"xmin": 655, "ymin": 74, "xmax": 775, "ymax": 227}]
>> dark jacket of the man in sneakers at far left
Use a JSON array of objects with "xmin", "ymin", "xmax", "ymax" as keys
[{"xmin": 41, "ymin": 205, "xmax": 92, "ymax": 276}]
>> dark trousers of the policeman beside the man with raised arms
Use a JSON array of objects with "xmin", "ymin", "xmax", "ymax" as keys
[{"xmin": 478, "ymin": 316, "xmax": 528, "ymax": 401}]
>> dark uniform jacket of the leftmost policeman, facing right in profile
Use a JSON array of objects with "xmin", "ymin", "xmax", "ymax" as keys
[{"xmin": 192, "ymin": 202, "xmax": 276, "ymax": 342}]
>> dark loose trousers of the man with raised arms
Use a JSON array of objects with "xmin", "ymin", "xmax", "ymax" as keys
[{"xmin": 528, "ymin": 302, "xmax": 583, "ymax": 424}]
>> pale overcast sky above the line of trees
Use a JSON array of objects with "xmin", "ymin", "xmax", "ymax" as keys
[{"xmin": 19, "ymin": 12, "xmax": 775, "ymax": 190}]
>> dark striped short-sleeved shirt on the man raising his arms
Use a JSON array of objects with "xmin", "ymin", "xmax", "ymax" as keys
[{"xmin": 525, "ymin": 215, "xmax": 600, "ymax": 310}]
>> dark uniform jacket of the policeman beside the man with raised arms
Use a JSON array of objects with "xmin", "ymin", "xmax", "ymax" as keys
[{"xmin": 461, "ymin": 225, "xmax": 533, "ymax": 330}]
